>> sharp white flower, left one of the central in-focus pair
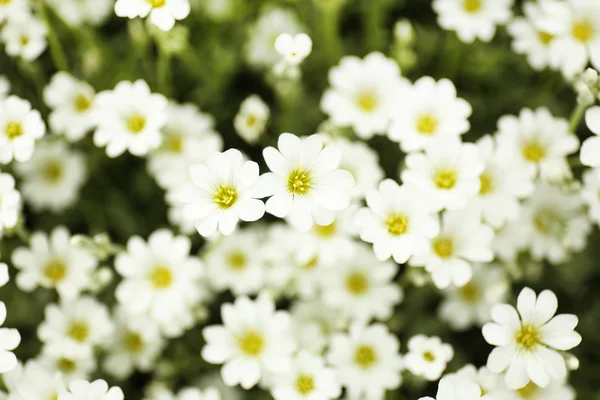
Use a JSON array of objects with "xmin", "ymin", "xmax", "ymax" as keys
[{"xmin": 177, "ymin": 149, "xmax": 265, "ymax": 236}]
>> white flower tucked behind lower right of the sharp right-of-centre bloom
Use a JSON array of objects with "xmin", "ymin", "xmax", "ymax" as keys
[{"xmin": 410, "ymin": 209, "xmax": 494, "ymax": 289}]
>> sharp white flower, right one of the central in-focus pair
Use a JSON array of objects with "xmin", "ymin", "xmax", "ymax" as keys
[{"xmin": 262, "ymin": 133, "xmax": 354, "ymax": 232}]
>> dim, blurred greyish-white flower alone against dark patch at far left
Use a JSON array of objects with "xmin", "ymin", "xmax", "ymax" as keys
[{"xmin": 15, "ymin": 141, "xmax": 87, "ymax": 213}]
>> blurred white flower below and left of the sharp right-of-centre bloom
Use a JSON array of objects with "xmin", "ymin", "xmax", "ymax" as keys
[{"xmin": 321, "ymin": 246, "xmax": 404, "ymax": 323}]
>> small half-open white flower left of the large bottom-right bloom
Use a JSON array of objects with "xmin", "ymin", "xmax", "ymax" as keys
[{"xmin": 404, "ymin": 335, "xmax": 454, "ymax": 381}]
